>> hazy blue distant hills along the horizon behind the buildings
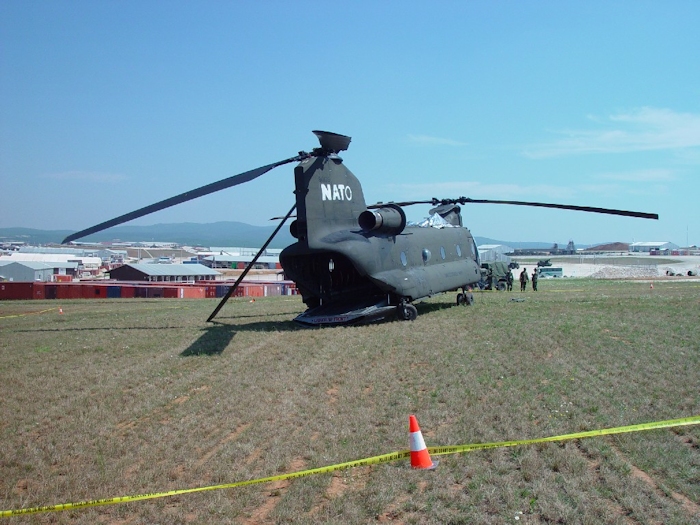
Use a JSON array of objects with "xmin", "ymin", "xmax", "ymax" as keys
[{"xmin": 0, "ymin": 221, "xmax": 582, "ymax": 249}]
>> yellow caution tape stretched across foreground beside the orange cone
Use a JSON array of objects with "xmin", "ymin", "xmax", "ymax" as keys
[{"xmin": 0, "ymin": 416, "xmax": 700, "ymax": 518}]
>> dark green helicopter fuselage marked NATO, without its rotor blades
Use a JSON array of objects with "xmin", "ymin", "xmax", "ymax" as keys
[{"xmin": 280, "ymin": 151, "xmax": 481, "ymax": 324}]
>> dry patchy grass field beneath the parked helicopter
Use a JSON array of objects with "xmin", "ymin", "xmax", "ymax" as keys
[{"xmin": 0, "ymin": 279, "xmax": 700, "ymax": 525}]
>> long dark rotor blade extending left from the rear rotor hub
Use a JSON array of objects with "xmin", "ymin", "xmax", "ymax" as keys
[{"xmin": 61, "ymin": 152, "xmax": 309, "ymax": 244}]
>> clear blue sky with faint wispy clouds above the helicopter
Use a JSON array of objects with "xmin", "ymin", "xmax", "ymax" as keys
[{"xmin": 0, "ymin": 0, "xmax": 700, "ymax": 246}]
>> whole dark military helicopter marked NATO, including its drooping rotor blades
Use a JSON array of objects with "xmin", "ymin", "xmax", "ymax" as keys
[{"xmin": 63, "ymin": 131, "xmax": 658, "ymax": 326}]
